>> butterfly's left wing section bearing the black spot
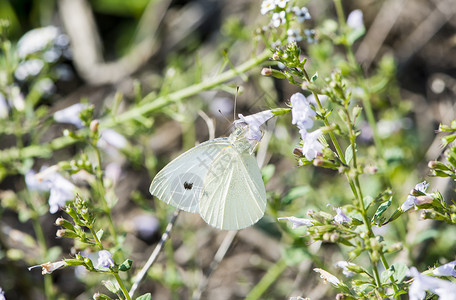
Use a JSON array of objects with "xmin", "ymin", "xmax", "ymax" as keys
[{"xmin": 149, "ymin": 138, "xmax": 230, "ymax": 212}]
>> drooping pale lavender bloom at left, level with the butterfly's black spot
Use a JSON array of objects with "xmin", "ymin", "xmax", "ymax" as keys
[{"xmin": 49, "ymin": 173, "xmax": 76, "ymax": 214}]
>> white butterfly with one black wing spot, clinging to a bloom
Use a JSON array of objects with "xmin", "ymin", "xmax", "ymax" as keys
[{"xmin": 149, "ymin": 126, "xmax": 266, "ymax": 230}]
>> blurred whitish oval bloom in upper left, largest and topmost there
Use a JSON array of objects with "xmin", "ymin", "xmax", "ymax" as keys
[{"xmin": 17, "ymin": 26, "xmax": 59, "ymax": 58}]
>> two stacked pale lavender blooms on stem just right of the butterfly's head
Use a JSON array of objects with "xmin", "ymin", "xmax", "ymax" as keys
[{"xmin": 290, "ymin": 93, "xmax": 324, "ymax": 161}]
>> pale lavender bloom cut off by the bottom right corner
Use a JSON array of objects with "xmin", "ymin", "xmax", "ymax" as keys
[{"xmin": 409, "ymin": 267, "xmax": 456, "ymax": 300}]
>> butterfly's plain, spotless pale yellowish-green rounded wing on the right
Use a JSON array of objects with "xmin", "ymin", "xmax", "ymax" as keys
[{"xmin": 199, "ymin": 146, "xmax": 266, "ymax": 230}]
